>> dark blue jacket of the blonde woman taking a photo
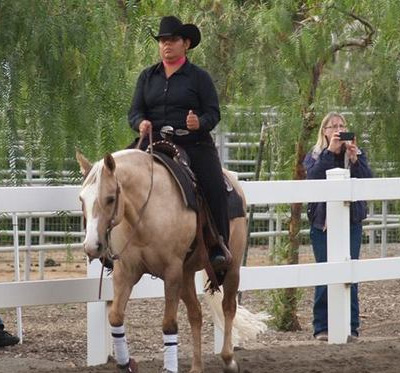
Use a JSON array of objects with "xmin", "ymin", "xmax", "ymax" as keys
[{"xmin": 303, "ymin": 149, "xmax": 372, "ymax": 229}]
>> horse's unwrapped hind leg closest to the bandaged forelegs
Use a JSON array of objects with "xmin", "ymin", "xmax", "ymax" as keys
[{"xmin": 181, "ymin": 273, "xmax": 203, "ymax": 373}]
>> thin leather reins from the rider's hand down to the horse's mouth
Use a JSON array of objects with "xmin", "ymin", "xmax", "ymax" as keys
[{"xmin": 99, "ymin": 131, "xmax": 154, "ymax": 299}]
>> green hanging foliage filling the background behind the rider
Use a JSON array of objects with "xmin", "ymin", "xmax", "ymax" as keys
[{"xmin": 0, "ymin": 0, "xmax": 400, "ymax": 181}]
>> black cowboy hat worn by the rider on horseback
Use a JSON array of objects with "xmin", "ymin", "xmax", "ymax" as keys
[{"xmin": 152, "ymin": 16, "xmax": 201, "ymax": 49}]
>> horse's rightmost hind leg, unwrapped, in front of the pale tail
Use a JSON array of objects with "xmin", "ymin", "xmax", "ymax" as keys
[{"xmin": 221, "ymin": 270, "xmax": 239, "ymax": 373}]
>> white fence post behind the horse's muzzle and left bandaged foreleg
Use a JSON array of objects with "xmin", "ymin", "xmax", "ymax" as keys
[{"xmin": 87, "ymin": 260, "xmax": 112, "ymax": 365}]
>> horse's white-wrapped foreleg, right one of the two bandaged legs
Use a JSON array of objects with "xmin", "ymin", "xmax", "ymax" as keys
[{"xmin": 162, "ymin": 263, "xmax": 182, "ymax": 373}]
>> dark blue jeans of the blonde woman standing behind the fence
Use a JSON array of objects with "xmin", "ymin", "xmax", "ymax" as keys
[{"xmin": 310, "ymin": 223, "xmax": 362, "ymax": 335}]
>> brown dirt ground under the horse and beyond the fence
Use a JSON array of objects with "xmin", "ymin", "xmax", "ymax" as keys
[{"xmin": 0, "ymin": 247, "xmax": 400, "ymax": 373}]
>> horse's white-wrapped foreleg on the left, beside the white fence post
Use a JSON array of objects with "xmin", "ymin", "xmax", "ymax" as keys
[{"xmin": 108, "ymin": 272, "xmax": 139, "ymax": 373}]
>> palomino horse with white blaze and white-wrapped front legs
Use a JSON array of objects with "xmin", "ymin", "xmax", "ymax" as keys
[{"xmin": 77, "ymin": 150, "xmax": 246, "ymax": 373}]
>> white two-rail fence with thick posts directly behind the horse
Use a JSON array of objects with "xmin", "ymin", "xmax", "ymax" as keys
[{"xmin": 0, "ymin": 169, "xmax": 400, "ymax": 365}]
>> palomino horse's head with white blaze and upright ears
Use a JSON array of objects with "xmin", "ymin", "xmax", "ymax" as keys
[{"xmin": 76, "ymin": 152, "xmax": 124, "ymax": 259}]
